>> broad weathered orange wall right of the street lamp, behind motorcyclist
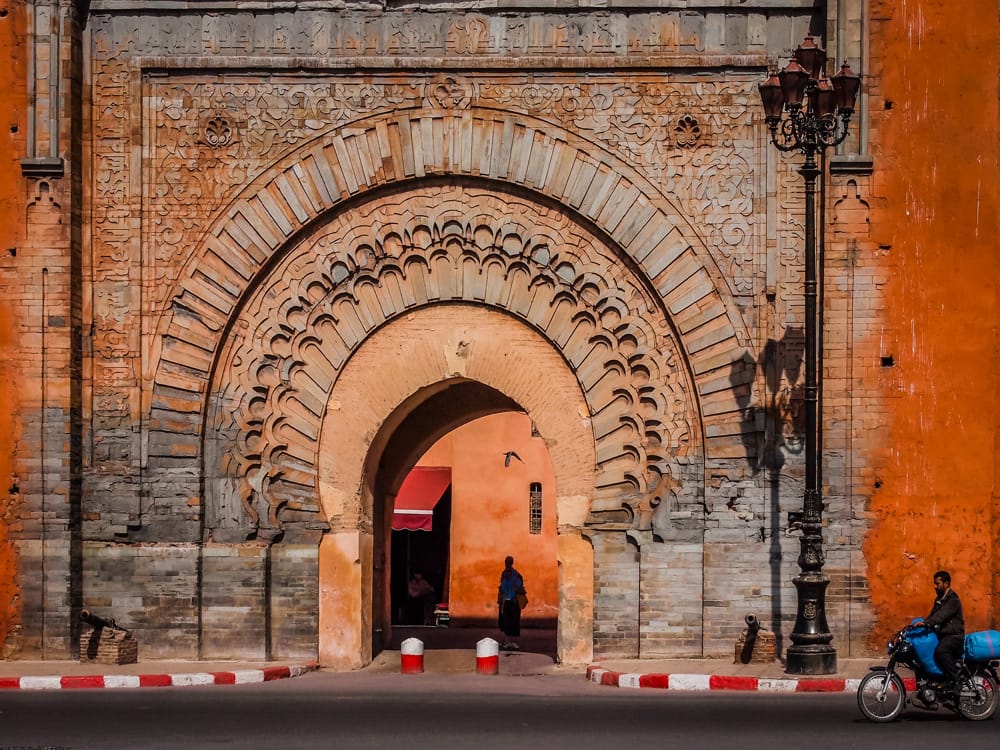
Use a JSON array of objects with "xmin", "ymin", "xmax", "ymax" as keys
[{"xmin": 864, "ymin": 0, "xmax": 1000, "ymax": 643}]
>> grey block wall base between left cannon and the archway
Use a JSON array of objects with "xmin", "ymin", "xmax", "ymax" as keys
[{"xmin": 80, "ymin": 542, "xmax": 318, "ymax": 661}]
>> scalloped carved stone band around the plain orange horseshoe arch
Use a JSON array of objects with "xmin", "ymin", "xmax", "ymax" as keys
[{"xmin": 204, "ymin": 185, "xmax": 704, "ymax": 541}]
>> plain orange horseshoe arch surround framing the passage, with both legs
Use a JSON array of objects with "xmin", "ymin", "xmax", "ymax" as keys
[{"xmin": 320, "ymin": 305, "xmax": 595, "ymax": 667}]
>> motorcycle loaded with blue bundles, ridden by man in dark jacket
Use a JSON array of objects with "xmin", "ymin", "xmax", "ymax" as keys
[{"xmin": 858, "ymin": 623, "xmax": 1000, "ymax": 722}]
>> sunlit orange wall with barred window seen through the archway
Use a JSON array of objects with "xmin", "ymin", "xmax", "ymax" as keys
[{"xmin": 418, "ymin": 413, "xmax": 559, "ymax": 620}]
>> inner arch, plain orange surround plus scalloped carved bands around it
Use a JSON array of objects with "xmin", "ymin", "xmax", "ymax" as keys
[{"xmin": 170, "ymin": 178, "xmax": 704, "ymax": 667}]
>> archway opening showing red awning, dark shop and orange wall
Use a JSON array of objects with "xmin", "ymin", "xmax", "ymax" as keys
[{"xmin": 376, "ymin": 410, "xmax": 559, "ymax": 656}]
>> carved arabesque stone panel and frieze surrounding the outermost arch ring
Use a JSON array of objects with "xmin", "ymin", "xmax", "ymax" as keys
[{"xmin": 86, "ymin": 13, "xmax": 808, "ymax": 548}]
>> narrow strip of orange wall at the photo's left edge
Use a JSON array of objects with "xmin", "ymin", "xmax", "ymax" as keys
[{"xmin": 0, "ymin": 0, "xmax": 26, "ymax": 658}]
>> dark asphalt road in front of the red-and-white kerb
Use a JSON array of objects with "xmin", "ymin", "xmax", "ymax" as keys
[{"xmin": 0, "ymin": 673, "xmax": 1000, "ymax": 750}]
